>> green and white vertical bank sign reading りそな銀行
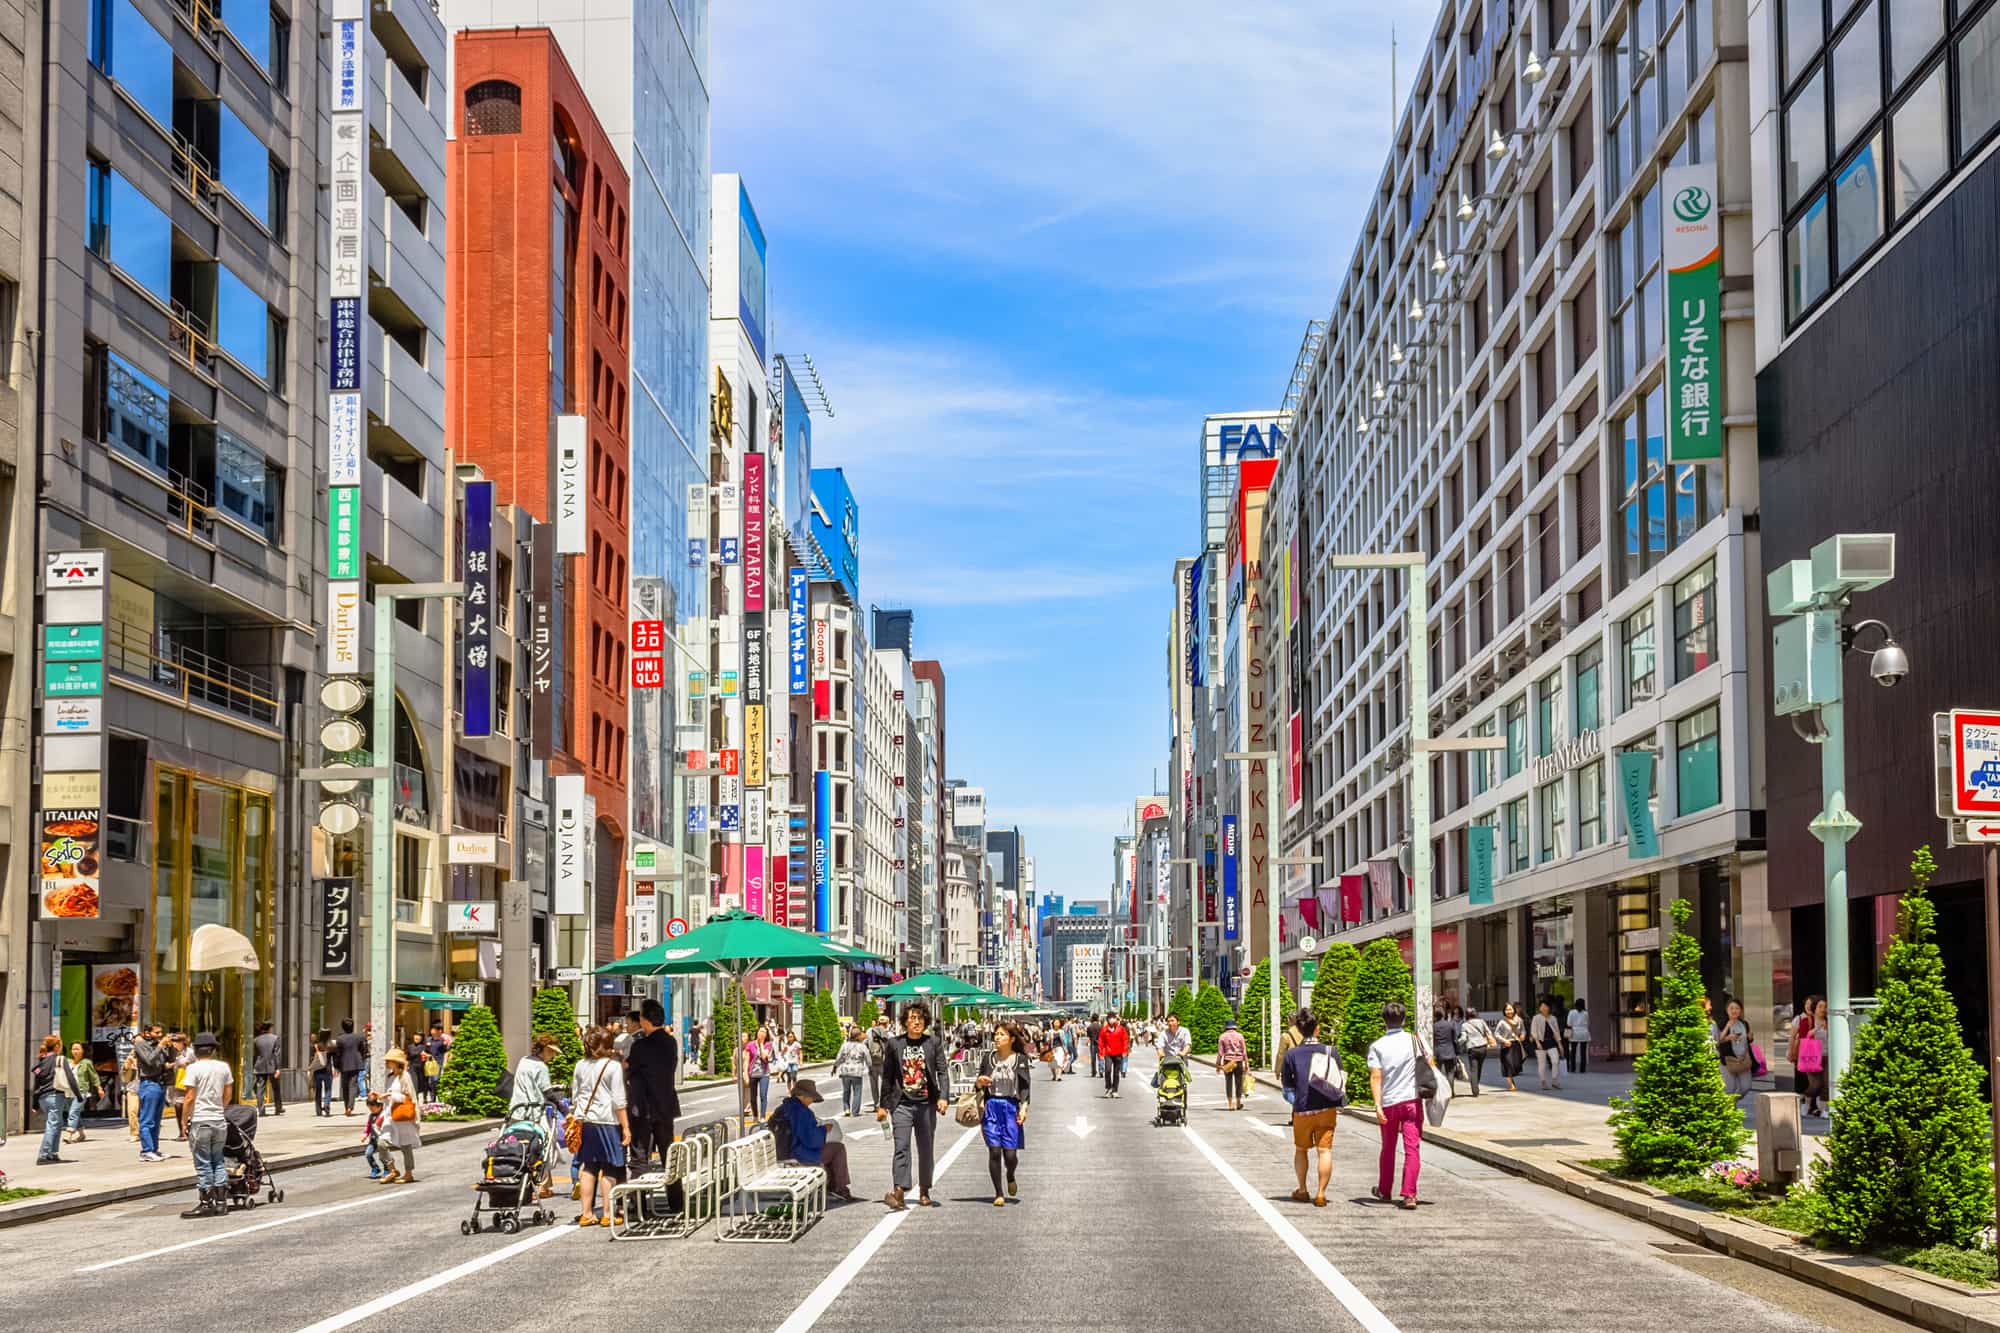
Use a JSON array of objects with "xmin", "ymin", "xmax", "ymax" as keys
[{"xmin": 1662, "ymin": 162, "xmax": 1722, "ymax": 462}]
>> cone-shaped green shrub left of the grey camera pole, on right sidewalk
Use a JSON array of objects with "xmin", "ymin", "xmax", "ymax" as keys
[{"xmin": 1610, "ymin": 899, "xmax": 1750, "ymax": 1177}]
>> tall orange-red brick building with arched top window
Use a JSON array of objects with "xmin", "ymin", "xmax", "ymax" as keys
[{"xmin": 444, "ymin": 28, "xmax": 632, "ymax": 961}]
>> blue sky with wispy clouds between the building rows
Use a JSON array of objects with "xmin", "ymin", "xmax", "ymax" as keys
[{"xmin": 710, "ymin": 0, "xmax": 1436, "ymax": 899}]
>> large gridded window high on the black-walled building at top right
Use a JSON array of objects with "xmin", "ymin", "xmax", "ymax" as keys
[{"xmin": 1778, "ymin": 0, "xmax": 2000, "ymax": 320}]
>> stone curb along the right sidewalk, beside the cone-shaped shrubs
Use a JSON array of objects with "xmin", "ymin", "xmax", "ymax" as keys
[{"xmin": 1252, "ymin": 1073, "xmax": 2000, "ymax": 1333}]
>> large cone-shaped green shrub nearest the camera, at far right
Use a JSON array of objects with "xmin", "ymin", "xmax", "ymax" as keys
[{"xmin": 1814, "ymin": 847, "xmax": 1994, "ymax": 1247}]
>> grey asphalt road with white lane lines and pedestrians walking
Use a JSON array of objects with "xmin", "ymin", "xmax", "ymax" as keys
[{"xmin": 0, "ymin": 1055, "xmax": 1904, "ymax": 1333}]
